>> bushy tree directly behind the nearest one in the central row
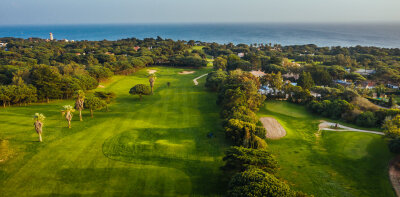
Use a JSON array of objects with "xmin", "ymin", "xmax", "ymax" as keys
[{"xmin": 222, "ymin": 146, "xmax": 278, "ymax": 174}]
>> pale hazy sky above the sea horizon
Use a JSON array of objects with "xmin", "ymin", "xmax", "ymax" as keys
[{"xmin": 0, "ymin": 0, "xmax": 400, "ymax": 24}]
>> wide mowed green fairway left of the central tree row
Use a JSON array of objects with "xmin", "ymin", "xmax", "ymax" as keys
[{"xmin": 0, "ymin": 67, "xmax": 229, "ymax": 196}]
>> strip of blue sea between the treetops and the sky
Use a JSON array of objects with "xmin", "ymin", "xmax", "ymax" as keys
[{"xmin": 0, "ymin": 24, "xmax": 400, "ymax": 48}]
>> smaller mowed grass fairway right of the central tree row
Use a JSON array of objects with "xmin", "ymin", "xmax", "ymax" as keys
[{"xmin": 259, "ymin": 101, "xmax": 395, "ymax": 197}]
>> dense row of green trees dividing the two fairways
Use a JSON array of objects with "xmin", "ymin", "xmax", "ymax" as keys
[{"xmin": 205, "ymin": 70, "xmax": 307, "ymax": 197}]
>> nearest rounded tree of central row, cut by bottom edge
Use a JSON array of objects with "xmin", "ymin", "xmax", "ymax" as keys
[{"xmin": 228, "ymin": 169, "xmax": 294, "ymax": 197}]
